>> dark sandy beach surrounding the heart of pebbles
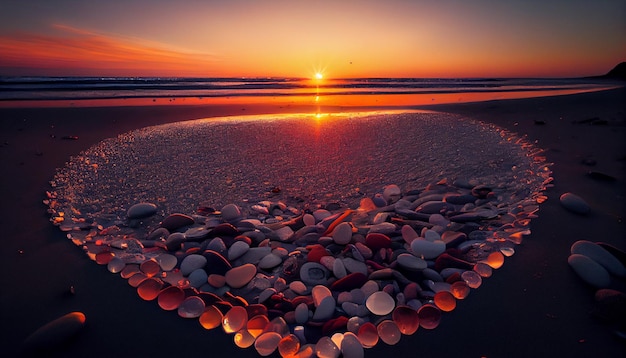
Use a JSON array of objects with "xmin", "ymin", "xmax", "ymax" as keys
[{"xmin": 0, "ymin": 88, "xmax": 626, "ymax": 357}]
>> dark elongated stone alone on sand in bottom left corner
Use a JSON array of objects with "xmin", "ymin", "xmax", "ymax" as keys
[{"xmin": 24, "ymin": 312, "xmax": 86, "ymax": 352}]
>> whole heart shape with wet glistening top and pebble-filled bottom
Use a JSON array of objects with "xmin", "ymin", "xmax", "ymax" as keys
[{"xmin": 45, "ymin": 112, "xmax": 551, "ymax": 357}]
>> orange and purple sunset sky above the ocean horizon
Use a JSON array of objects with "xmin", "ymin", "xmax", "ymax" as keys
[{"xmin": 0, "ymin": 0, "xmax": 626, "ymax": 78}]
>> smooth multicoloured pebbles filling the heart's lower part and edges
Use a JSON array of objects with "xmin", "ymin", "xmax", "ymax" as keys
[{"xmin": 45, "ymin": 111, "xmax": 551, "ymax": 357}]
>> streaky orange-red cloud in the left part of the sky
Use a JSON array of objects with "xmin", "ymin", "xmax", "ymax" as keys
[{"xmin": 0, "ymin": 24, "xmax": 221, "ymax": 76}]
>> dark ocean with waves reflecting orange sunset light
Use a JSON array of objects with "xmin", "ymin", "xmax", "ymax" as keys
[{"xmin": 0, "ymin": 77, "xmax": 611, "ymax": 106}]
